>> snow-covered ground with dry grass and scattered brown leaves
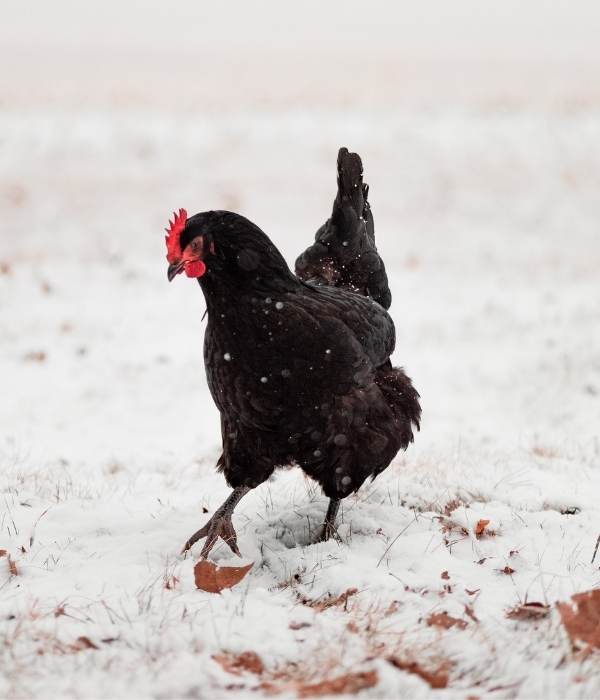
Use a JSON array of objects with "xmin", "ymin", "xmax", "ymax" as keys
[{"xmin": 0, "ymin": 2, "xmax": 600, "ymax": 699}]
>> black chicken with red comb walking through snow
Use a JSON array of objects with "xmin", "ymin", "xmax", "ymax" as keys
[{"xmin": 167, "ymin": 148, "xmax": 421, "ymax": 557}]
